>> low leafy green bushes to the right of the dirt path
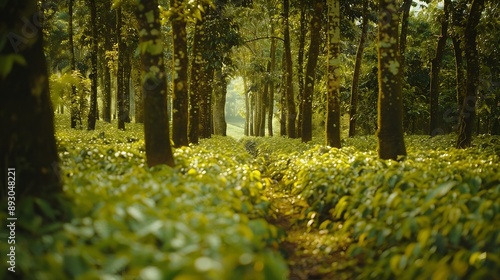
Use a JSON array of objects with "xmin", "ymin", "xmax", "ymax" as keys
[{"xmin": 252, "ymin": 136, "xmax": 500, "ymax": 279}]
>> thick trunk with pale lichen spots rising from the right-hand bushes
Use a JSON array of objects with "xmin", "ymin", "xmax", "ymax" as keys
[{"xmin": 377, "ymin": 0, "xmax": 406, "ymax": 160}]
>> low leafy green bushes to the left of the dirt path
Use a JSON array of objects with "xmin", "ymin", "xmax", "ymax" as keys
[{"xmin": 0, "ymin": 116, "xmax": 287, "ymax": 280}]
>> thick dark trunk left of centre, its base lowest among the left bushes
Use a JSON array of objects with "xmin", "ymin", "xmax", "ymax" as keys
[{"xmin": 135, "ymin": 0, "xmax": 174, "ymax": 167}]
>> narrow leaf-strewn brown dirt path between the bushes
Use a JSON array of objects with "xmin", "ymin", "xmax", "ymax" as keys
[{"xmin": 266, "ymin": 187, "xmax": 351, "ymax": 280}]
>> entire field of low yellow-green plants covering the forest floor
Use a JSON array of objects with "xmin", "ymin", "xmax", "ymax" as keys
[{"xmin": 0, "ymin": 117, "xmax": 500, "ymax": 280}]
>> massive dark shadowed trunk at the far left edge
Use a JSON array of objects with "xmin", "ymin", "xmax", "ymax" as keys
[{"xmin": 0, "ymin": 0, "xmax": 63, "ymax": 200}]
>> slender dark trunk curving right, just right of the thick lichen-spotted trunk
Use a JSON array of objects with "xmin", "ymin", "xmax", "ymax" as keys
[{"xmin": 429, "ymin": 0, "xmax": 450, "ymax": 136}]
